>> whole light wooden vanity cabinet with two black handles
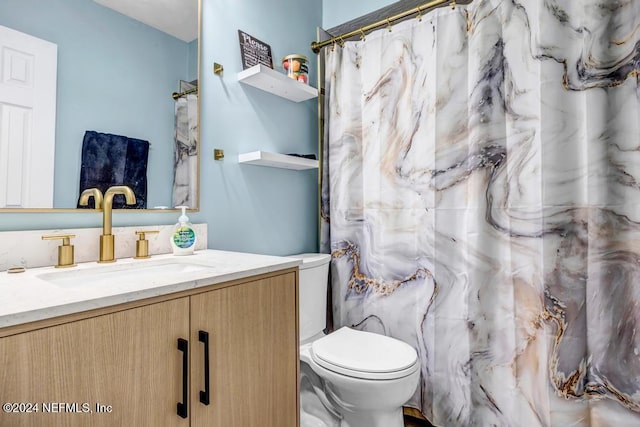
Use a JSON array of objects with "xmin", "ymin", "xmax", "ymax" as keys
[{"xmin": 0, "ymin": 269, "xmax": 299, "ymax": 427}]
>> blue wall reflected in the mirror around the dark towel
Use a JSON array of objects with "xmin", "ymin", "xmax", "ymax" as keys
[{"xmin": 0, "ymin": 0, "xmax": 192, "ymax": 208}]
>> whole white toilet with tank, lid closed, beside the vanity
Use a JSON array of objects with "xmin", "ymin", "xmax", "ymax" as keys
[{"xmin": 290, "ymin": 254, "xmax": 420, "ymax": 427}]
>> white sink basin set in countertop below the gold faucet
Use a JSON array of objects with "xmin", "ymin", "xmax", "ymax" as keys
[{"xmin": 37, "ymin": 260, "xmax": 216, "ymax": 288}]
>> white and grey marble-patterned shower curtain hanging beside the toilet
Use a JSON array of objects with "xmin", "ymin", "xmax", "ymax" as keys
[{"xmin": 322, "ymin": 0, "xmax": 640, "ymax": 427}]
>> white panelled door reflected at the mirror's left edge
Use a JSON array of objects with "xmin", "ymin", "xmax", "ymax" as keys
[{"xmin": 0, "ymin": 25, "xmax": 58, "ymax": 208}]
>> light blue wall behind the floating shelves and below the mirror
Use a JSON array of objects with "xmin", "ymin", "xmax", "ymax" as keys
[{"xmin": 0, "ymin": 0, "xmax": 322, "ymax": 255}]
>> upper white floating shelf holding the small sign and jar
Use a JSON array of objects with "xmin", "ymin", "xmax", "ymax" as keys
[{"xmin": 238, "ymin": 64, "xmax": 318, "ymax": 102}]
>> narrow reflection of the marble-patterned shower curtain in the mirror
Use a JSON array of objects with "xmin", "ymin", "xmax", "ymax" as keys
[{"xmin": 172, "ymin": 94, "xmax": 198, "ymax": 208}]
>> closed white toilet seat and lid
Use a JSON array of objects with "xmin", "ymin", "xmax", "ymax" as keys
[{"xmin": 310, "ymin": 327, "xmax": 420, "ymax": 380}]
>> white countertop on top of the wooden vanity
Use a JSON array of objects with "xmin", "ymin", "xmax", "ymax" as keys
[{"xmin": 0, "ymin": 249, "xmax": 302, "ymax": 328}]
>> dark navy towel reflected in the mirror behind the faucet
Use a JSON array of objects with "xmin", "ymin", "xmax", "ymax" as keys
[{"xmin": 78, "ymin": 131, "xmax": 149, "ymax": 209}]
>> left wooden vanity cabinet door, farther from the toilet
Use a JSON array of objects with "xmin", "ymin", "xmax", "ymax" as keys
[{"xmin": 0, "ymin": 298, "xmax": 189, "ymax": 427}]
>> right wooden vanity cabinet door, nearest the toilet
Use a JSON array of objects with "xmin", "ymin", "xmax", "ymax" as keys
[{"xmin": 191, "ymin": 273, "xmax": 299, "ymax": 427}]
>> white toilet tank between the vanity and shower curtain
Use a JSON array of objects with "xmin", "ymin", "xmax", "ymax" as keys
[{"xmin": 289, "ymin": 254, "xmax": 331, "ymax": 343}]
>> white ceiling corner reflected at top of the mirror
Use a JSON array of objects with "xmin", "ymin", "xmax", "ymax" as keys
[{"xmin": 94, "ymin": 0, "xmax": 198, "ymax": 42}]
